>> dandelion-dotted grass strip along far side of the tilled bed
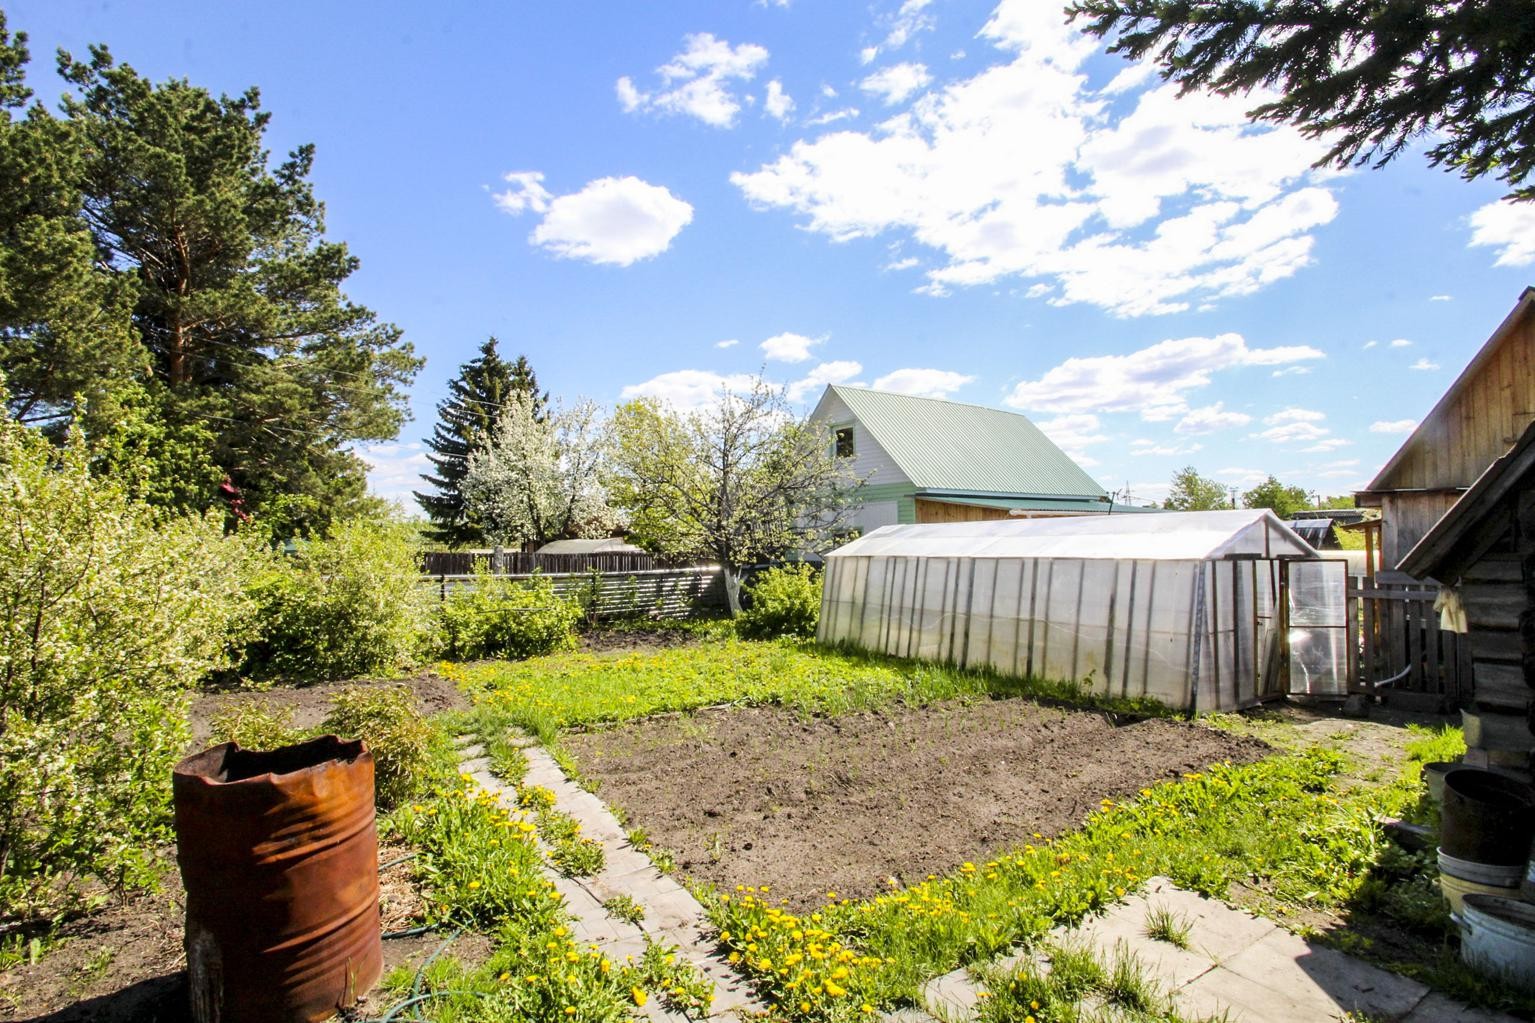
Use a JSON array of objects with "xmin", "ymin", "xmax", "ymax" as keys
[{"xmin": 437, "ymin": 636, "xmax": 1176, "ymax": 742}]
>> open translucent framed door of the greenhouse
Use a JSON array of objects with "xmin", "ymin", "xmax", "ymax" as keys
[{"xmin": 1280, "ymin": 561, "xmax": 1348, "ymax": 697}]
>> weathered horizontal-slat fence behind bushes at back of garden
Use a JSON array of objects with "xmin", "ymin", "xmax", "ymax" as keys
[{"xmin": 425, "ymin": 565, "xmax": 725, "ymax": 617}]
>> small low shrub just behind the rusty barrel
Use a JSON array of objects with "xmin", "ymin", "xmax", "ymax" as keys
[{"xmin": 321, "ymin": 685, "xmax": 434, "ymax": 808}]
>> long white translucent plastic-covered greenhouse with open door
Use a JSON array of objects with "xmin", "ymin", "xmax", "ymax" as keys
[{"xmin": 818, "ymin": 508, "xmax": 1348, "ymax": 711}]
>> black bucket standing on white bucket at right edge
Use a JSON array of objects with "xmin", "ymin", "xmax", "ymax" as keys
[{"xmin": 1440, "ymin": 768, "xmax": 1535, "ymax": 866}]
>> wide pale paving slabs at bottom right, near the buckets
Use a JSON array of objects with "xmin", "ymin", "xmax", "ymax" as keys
[{"xmin": 886, "ymin": 877, "xmax": 1517, "ymax": 1023}]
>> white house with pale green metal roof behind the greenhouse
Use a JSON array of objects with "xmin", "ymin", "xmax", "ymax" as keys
[{"xmin": 810, "ymin": 386, "xmax": 1125, "ymax": 533}]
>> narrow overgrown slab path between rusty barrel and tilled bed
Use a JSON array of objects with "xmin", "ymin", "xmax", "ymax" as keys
[{"xmin": 459, "ymin": 739, "xmax": 768, "ymax": 1023}]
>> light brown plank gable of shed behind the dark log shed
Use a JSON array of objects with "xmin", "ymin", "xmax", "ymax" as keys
[{"xmin": 1355, "ymin": 287, "xmax": 1535, "ymax": 568}]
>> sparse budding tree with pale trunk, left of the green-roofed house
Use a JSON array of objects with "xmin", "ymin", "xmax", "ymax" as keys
[{"xmin": 608, "ymin": 379, "xmax": 860, "ymax": 614}]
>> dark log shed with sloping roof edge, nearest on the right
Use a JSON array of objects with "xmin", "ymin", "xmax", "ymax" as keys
[{"xmin": 1401, "ymin": 417, "xmax": 1535, "ymax": 710}]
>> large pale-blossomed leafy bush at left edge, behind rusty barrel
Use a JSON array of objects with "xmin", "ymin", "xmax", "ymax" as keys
[{"xmin": 0, "ymin": 416, "xmax": 253, "ymax": 917}]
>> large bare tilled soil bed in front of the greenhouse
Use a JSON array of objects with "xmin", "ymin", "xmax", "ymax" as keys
[{"xmin": 562, "ymin": 699, "xmax": 1269, "ymax": 908}]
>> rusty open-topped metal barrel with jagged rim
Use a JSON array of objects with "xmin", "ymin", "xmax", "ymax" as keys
[{"xmin": 173, "ymin": 736, "xmax": 384, "ymax": 1023}]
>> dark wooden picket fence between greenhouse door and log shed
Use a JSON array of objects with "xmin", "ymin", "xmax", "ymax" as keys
[{"xmin": 1348, "ymin": 571, "xmax": 1471, "ymax": 705}]
